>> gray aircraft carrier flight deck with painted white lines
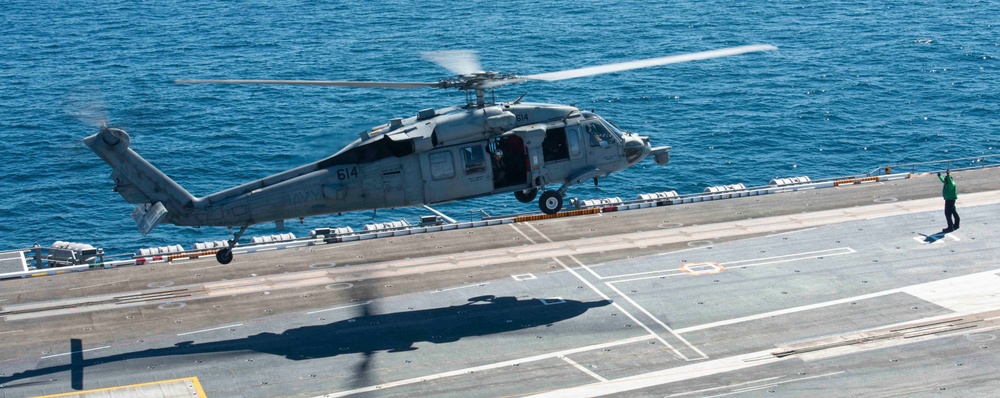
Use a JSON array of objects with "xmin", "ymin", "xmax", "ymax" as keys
[{"xmin": 0, "ymin": 168, "xmax": 1000, "ymax": 397}]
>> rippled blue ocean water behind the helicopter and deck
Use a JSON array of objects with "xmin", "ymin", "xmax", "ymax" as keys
[{"xmin": 0, "ymin": 0, "xmax": 1000, "ymax": 253}]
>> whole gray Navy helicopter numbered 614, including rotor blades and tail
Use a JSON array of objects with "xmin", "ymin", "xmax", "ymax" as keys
[{"xmin": 83, "ymin": 45, "xmax": 776, "ymax": 264}]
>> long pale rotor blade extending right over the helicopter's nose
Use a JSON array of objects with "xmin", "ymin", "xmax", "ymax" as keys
[{"xmin": 520, "ymin": 44, "xmax": 778, "ymax": 82}]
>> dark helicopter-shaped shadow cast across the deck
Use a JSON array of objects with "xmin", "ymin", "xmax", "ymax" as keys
[{"xmin": 0, "ymin": 296, "xmax": 611, "ymax": 390}]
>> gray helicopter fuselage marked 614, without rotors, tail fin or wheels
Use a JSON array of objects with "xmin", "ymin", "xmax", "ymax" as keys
[{"xmin": 156, "ymin": 104, "xmax": 649, "ymax": 226}]
